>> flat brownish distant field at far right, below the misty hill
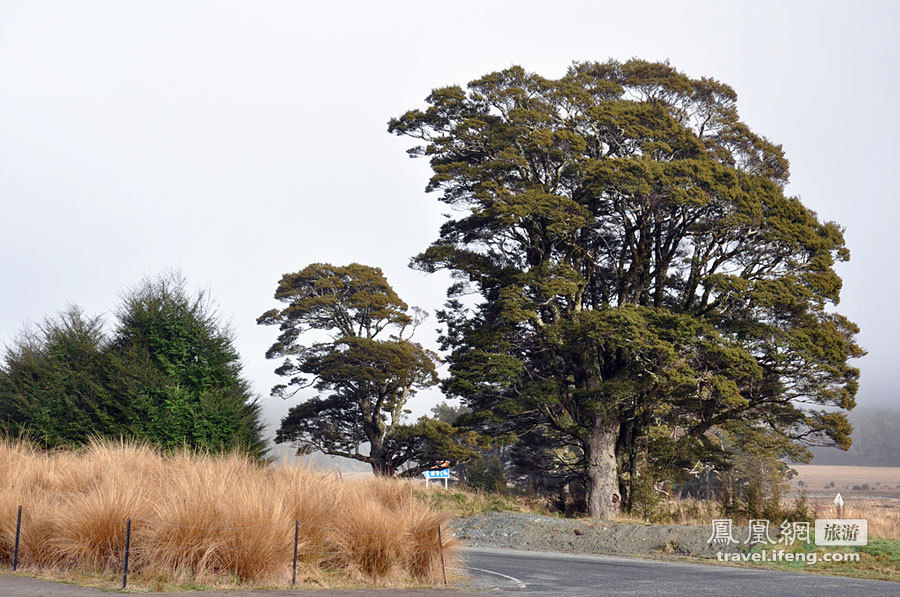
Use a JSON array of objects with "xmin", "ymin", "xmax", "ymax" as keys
[{"xmin": 791, "ymin": 464, "xmax": 900, "ymax": 498}]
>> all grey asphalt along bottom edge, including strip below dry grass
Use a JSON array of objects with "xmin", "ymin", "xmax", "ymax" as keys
[{"xmin": 0, "ymin": 548, "xmax": 900, "ymax": 597}]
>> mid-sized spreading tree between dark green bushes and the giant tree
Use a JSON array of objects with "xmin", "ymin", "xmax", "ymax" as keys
[{"xmin": 258, "ymin": 263, "xmax": 437, "ymax": 475}]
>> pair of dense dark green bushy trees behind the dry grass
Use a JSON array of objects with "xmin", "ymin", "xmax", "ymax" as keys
[{"xmin": 0, "ymin": 275, "xmax": 265, "ymax": 457}]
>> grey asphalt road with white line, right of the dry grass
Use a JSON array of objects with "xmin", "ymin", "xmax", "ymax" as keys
[{"xmin": 466, "ymin": 548, "xmax": 900, "ymax": 597}]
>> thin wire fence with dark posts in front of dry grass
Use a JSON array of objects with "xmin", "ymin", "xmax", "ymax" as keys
[{"xmin": 3, "ymin": 505, "xmax": 447, "ymax": 591}]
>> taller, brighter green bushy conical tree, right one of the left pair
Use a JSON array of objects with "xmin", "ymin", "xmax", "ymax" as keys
[{"xmin": 112, "ymin": 274, "xmax": 266, "ymax": 457}]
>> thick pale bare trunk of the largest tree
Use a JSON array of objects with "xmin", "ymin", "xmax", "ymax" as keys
[{"xmin": 584, "ymin": 418, "xmax": 622, "ymax": 519}]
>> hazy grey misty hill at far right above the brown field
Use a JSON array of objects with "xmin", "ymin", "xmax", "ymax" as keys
[{"xmin": 812, "ymin": 407, "xmax": 900, "ymax": 466}]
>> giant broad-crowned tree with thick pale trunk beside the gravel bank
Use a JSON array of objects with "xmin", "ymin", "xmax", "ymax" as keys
[{"xmin": 389, "ymin": 60, "xmax": 862, "ymax": 517}]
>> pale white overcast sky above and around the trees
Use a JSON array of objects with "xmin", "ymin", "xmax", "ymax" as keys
[{"xmin": 0, "ymin": 0, "xmax": 900, "ymax": 440}]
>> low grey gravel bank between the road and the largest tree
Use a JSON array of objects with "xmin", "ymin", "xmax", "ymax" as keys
[{"xmin": 451, "ymin": 512, "xmax": 747, "ymax": 557}]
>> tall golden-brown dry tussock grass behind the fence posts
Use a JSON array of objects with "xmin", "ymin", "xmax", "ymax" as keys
[{"xmin": 0, "ymin": 441, "xmax": 455, "ymax": 586}]
